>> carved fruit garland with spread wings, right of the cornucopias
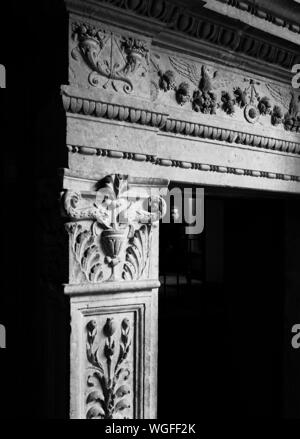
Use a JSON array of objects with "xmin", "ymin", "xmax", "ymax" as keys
[{"xmin": 151, "ymin": 55, "xmax": 300, "ymax": 131}]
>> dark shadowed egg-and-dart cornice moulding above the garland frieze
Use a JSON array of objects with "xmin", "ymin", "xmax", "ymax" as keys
[{"xmin": 68, "ymin": 0, "xmax": 300, "ymax": 71}]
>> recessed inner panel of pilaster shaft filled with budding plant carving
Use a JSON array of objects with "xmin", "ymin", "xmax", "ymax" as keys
[{"xmin": 85, "ymin": 313, "xmax": 136, "ymax": 419}]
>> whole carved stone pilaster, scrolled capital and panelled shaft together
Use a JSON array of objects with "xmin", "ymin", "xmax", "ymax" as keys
[{"xmin": 62, "ymin": 175, "xmax": 167, "ymax": 419}]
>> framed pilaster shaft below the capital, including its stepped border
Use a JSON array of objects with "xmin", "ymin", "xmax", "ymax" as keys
[{"xmin": 71, "ymin": 291, "xmax": 156, "ymax": 419}]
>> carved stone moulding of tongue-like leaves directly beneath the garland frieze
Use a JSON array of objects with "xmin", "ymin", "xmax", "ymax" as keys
[{"xmin": 62, "ymin": 91, "xmax": 300, "ymax": 155}]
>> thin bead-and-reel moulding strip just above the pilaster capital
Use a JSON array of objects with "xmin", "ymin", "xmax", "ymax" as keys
[{"xmin": 68, "ymin": 145, "xmax": 300, "ymax": 183}]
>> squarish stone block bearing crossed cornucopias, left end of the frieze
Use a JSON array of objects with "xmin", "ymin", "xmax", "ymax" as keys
[{"xmin": 70, "ymin": 21, "xmax": 149, "ymax": 94}]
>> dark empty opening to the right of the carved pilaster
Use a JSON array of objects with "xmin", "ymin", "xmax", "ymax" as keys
[{"xmin": 158, "ymin": 187, "xmax": 300, "ymax": 420}]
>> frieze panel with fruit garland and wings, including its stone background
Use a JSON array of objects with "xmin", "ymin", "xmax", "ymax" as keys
[{"xmin": 151, "ymin": 54, "xmax": 300, "ymax": 132}]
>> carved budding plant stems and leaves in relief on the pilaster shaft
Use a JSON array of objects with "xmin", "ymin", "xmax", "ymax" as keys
[{"xmin": 86, "ymin": 318, "xmax": 132, "ymax": 419}]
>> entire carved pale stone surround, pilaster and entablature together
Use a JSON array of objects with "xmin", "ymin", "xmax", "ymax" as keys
[{"xmin": 61, "ymin": 0, "xmax": 300, "ymax": 419}]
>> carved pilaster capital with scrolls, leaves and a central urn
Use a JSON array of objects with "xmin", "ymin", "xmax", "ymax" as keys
[{"xmin": 63, "ymin": 174, "xmax": 166, "ymax": 284}]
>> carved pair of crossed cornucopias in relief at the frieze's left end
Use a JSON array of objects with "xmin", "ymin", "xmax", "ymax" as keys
[{"xmin": 72, "ymin": 23, "xmax": 149, "ymax": 93}]
